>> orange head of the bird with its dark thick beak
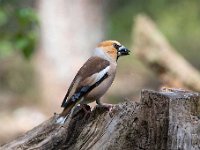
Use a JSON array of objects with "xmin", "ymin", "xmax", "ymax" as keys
[{"xmin": 97, "ymin": 40, "xmax": 130, "ymax": 61}]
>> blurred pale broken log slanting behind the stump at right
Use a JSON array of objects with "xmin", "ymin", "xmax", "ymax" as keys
[{"xmin": 133, "ymin": 15, "xmax": 200, "ymax": 92}]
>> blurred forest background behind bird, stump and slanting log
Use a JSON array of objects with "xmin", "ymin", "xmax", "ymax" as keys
[{"xmin": 0, "ymin": 0, "xmax": 200, "ymax": 144}]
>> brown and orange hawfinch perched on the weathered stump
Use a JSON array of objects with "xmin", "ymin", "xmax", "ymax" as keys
[{"xmin": 57, "ymin": 40, "xmax": 130, "ymax": 123}]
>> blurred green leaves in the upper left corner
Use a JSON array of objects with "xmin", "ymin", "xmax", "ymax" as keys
[{"xmin": 0, "ymin": 0, "xmax": 38, "ymax": 59}]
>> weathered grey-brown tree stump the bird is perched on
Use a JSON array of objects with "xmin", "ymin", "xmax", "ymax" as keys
[{"xmin": 1, "ymin": 89, "xmax": 200, "ymax": 150}]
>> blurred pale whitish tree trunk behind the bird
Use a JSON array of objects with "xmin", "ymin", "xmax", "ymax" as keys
[{"xmin": 34, "ymin": 0, "xmax": 104, "ymax": 112}]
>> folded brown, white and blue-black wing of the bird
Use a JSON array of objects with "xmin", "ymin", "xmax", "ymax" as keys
[{"xmin": 61, "ymin": 57, "xmax": 110, "ymax": 107}]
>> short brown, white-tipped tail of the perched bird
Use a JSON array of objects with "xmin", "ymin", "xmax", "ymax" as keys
[{"xmin": 56, "ymin": 103, "xmax": 76, "ymax": 124}]
